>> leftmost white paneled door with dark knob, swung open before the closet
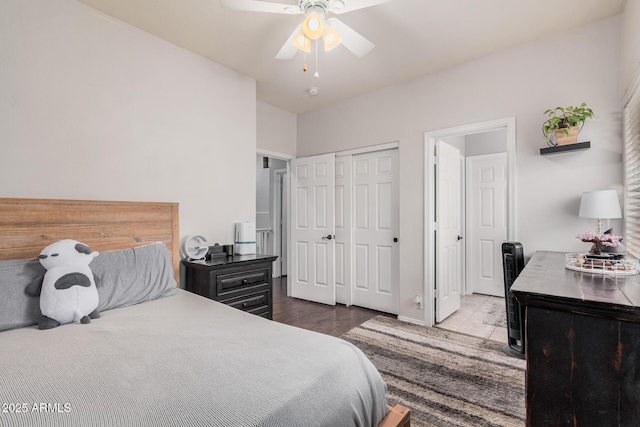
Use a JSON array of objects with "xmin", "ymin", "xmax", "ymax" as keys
[{"xmin": 289, "ymin": 154, "xmax": 336, "ymax": 305}]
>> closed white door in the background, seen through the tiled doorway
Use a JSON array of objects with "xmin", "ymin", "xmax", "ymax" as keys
[{"xmin": 466, "ymin": 153, "xmax": 507, "ymax": 297}]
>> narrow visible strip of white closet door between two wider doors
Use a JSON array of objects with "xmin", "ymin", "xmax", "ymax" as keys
[{"xmin": 335, "ymin": 155, "xmax": 352, "ymax": 306}]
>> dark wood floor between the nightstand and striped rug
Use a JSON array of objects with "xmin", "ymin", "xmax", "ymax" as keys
[{"xmin": 273, "ymin": 277, "xmax": 384, "ymax": 337}]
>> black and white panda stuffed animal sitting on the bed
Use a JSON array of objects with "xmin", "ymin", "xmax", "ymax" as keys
[{"xmin": 26, "ymin": 239, "xmax": 100, "ymax": 329}]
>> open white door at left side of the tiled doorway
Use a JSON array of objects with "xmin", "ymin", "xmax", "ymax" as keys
[{"xmin": 435, "ymin": 140, "xmax": 462, "ymax": 322}]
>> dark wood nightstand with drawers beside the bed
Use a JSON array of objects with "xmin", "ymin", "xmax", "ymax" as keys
[{"xmin": 182, "ymin": 255, "xmax": 278, "ymax": 319}]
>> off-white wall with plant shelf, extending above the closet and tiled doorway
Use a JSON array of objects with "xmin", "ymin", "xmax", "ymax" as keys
[{"xmin": 297, "ymin": 16, "xmax": 622, "ymax": 320}]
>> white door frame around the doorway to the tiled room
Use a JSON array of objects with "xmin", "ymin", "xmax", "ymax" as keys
[{"xmin": 424, "ymin": 116, "xmax": 517, "ymax": 326}]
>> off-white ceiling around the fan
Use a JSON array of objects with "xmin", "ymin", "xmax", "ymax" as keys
[{"xmin": 79, "ymin": 0, "xmax": 626, "ymax": 113}]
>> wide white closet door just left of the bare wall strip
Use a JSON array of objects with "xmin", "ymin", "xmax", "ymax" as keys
[{"xmin": 352, "ymin": 149, "xmax": 400, "ymax": 314}]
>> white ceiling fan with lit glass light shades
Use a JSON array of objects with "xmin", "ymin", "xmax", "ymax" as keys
[{"xmin": 220, "ymin": 0, "xmax": 392, "ymax": 59}]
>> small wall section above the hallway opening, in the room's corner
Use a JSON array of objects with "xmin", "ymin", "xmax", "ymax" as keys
[{"xmin": 257, "ymin": 101, "xmax": 297, "ymax": 157}]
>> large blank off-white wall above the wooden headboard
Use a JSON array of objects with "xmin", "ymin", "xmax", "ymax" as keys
[{"xmin": 0, "ymin": 0, "xmax": 256, "ymax": 254}]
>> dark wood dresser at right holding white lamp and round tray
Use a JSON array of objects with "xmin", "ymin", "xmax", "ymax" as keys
[{"xmin": 511, "ymin": 252, "xmax": 640, "ymax": 427}]
